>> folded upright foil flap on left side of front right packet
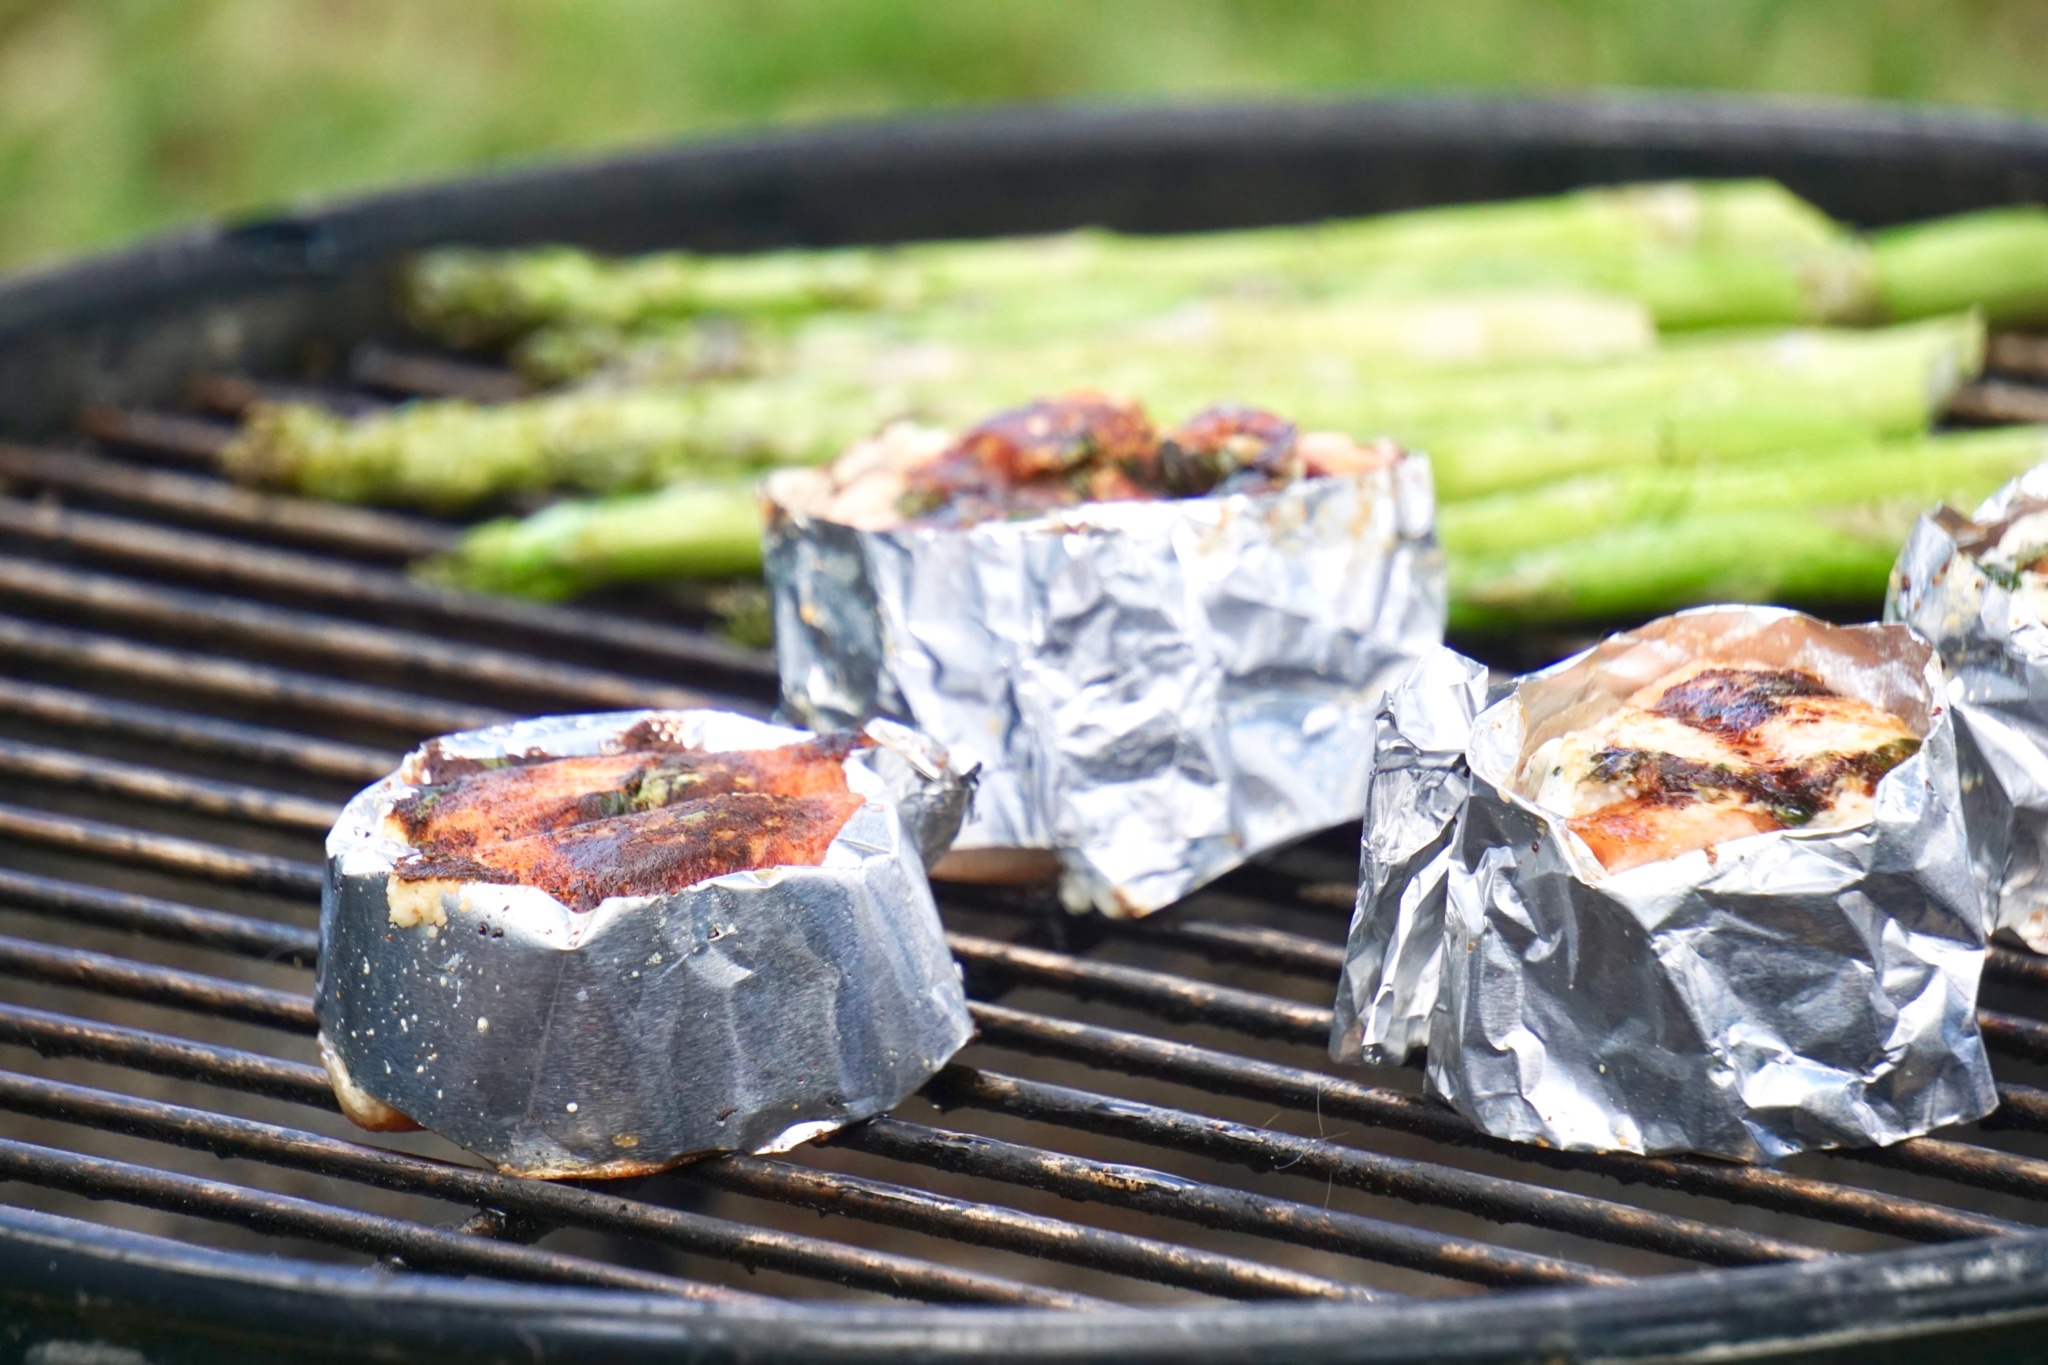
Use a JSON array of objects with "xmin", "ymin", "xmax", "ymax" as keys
[{"xmin": 1329, "ymin": 647, "xmax": 1489, "ymax": 1064}]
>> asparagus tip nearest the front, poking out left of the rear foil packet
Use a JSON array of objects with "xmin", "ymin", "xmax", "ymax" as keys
[{"xmin": 418, "ymin": 477, "xmax": 762, "ymax": 602}]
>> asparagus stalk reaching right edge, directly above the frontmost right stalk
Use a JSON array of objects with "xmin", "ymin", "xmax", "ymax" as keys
[{"xmin": 1438, "ymin": 426, "xmax": 2048, "ymax": 560}]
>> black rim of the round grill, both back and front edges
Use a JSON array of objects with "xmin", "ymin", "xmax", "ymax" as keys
[{"xmin": 12, "ymin": 96, "xmax": 2048, "ymax": 1361}]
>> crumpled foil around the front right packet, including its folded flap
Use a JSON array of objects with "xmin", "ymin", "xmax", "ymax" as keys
[{"xmin": 1331, "ymin": 606, "xmax": 1997, "ymax": 1160}]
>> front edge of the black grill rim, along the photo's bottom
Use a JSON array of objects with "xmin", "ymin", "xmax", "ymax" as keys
[{"xmin": 0, "ymin": 1207, "xmax": 2048, "ymax": 1365}]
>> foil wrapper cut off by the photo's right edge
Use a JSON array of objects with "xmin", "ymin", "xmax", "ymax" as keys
[{"xmin": 1884, "ymin": 465, "xmax": 2048, "ymax": 952}]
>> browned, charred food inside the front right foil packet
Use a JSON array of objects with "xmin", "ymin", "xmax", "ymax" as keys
[{"xmin": 1520, "ymin": 659, "xmax": 1919, "ymax": 872}]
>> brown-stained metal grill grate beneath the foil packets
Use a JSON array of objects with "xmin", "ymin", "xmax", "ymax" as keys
[{"xmin": 0, "ymin": 347, "xmax": 2048, "ymax": 1310}]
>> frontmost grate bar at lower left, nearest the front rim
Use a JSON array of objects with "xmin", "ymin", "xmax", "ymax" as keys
[{"xmin": 0, "ymin": 1138, "xmax": 756, "ymax": 1302}]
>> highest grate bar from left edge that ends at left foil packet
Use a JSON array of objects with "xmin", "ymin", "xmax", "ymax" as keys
[{"xmin": 0, "ymin": 677, "xmax": 399, "ymax": 784}]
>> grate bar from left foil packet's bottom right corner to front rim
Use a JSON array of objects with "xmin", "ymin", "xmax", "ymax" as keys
[{"xmin": 825, "ymin": 1117, "xmax": 1628, "ymax": 1285}]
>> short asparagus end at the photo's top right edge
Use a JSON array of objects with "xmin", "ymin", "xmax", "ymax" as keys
[{"xmin": 1872, "ymin": 207, "xmax": 2048, "ymax": 325}]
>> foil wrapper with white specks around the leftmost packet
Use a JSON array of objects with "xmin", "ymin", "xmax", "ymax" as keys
[{"xmin": 317, "ymin": 710, "xmax": 973, "ymax": 1177}]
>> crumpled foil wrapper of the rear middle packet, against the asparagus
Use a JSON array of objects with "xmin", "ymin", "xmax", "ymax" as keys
[{"xmin": 766, "ymin": 456, "xmax": 1446, "ymax": 915}]
